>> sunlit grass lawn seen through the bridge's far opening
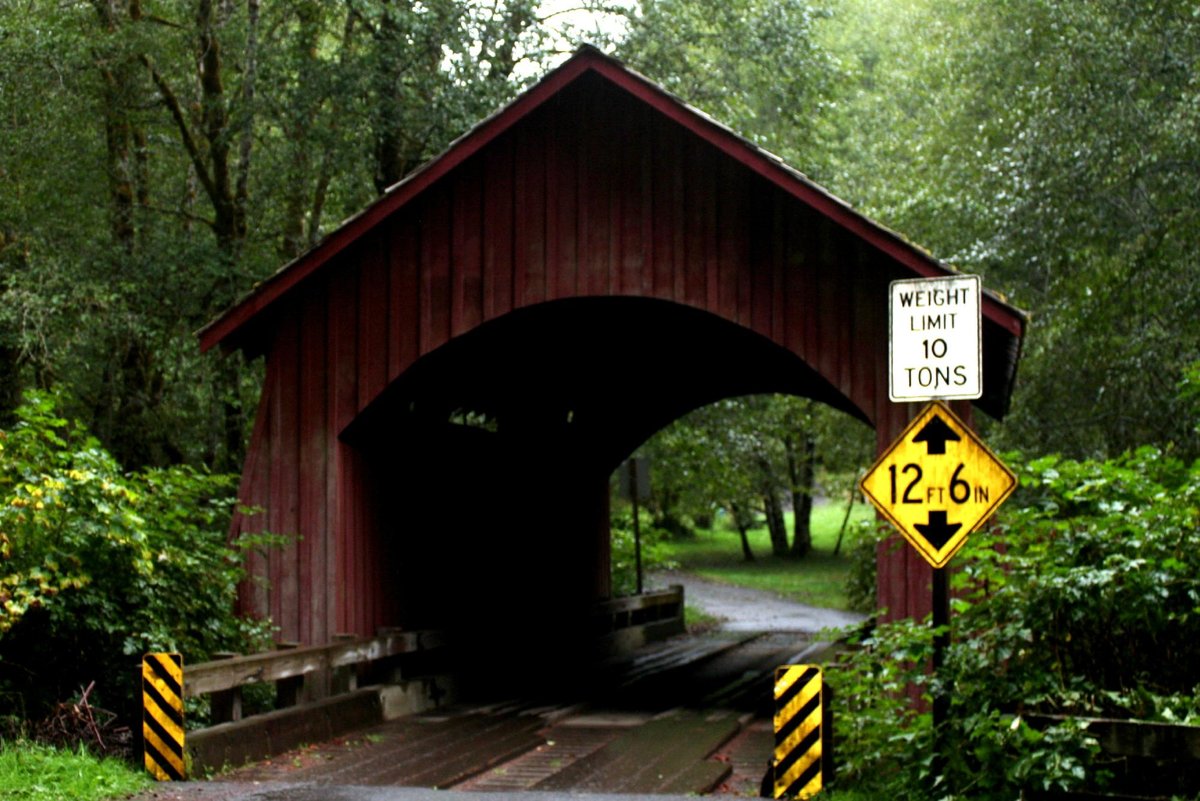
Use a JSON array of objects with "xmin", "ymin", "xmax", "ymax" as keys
[{"xmin": 662, "ymin": 502, "xmax": 875, "ymax": 609}]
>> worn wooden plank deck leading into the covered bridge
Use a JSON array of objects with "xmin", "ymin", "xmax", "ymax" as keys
[{"xmin": 213, "ymin": 637, "xmax": 816, "ymax": 795}]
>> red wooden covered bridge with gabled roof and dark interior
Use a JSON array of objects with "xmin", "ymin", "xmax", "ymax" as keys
[{"xmin": 202, "ymin": 48, "xmax": 1025, "ymax": 643}]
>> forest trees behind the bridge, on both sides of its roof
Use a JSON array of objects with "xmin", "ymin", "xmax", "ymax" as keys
[{"xmin": 0, "ymin": 0, "xmax": 1200, "ymax": 472}]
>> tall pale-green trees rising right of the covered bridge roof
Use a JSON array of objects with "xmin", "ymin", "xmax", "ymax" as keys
[{"xmin": 821, "ymin": 0, "xmax": 1200, "ymax": 456}]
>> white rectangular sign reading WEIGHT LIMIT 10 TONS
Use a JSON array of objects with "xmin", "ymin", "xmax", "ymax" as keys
[{"xmin": 888, "ymin": 276, "xmax": 983, "ymax": 403}]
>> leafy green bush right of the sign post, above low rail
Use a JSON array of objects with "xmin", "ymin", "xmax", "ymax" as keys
[{"xmin": 955, "ymin": 447, "xmax": 1200, "ymax": 718}]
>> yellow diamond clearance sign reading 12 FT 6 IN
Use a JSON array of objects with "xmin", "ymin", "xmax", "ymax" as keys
[{"xmin": 860, "ymin": 401, "xmax": 1016, "ymax": 567}]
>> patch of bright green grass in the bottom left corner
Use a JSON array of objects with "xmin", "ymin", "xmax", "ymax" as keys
[{"xmin": 0, "ymin": 740, "xmax": 150, "ymax": 801}]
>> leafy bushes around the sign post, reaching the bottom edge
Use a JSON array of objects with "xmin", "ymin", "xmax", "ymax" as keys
[{"xmin": 828, "ymin": 448, "xmax": 1200, "ymax": 799}]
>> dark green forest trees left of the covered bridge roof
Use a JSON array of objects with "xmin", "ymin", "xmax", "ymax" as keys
[{"xmin": 0, "ymin": 0, "xmax": 590, "ymax": 469}]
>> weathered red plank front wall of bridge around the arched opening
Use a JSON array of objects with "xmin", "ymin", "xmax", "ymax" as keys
[{"xmin": 226, "ymin": 71, "xmax": 928, "ymax": 642}]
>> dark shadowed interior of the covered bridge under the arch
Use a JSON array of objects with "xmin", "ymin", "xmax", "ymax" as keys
[{"xmin": 343, "ymin": 297, "xmax": 862, "ymax": 681}]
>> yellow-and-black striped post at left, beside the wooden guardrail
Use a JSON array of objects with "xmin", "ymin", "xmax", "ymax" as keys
[{"xmin": 142, "ymin": 654, "xmax": 187, "ymax": 782}]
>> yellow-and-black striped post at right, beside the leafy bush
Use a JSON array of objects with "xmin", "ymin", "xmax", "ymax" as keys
[{"xmin": 773, "ymin": 664, "xmax": 824, "ymax": 799}]
